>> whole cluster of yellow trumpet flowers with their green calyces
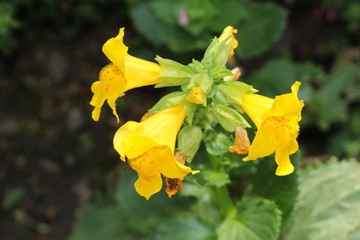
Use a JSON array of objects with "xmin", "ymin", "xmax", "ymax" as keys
[{"xmin": 90, "ymin": 26, "xmax": 304, "ymax": 199}]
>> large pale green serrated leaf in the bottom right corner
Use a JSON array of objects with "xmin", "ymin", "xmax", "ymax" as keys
[{"xmin": 284, "ymin": 158, "xmax": 360, "ymax": 240}]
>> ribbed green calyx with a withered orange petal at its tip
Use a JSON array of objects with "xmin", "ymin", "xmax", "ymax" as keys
[{"xmin": 214, "ymin": 105, "xmax": 250, "ymax": 132}]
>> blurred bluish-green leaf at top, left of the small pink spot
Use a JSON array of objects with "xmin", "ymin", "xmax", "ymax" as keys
[{"xmin": 130, "ymin": 3, "xmax": 163, "ymax": 46}]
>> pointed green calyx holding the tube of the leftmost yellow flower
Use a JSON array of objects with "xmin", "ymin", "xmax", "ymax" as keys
[{"xmin": 155, "ymin": 56, "xmax": 192, "ymax": 88}]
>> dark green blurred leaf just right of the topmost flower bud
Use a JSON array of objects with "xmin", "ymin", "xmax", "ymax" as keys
[{"xmin": 236, "ymin": 2, "xmax": 287, "ymax": 59}]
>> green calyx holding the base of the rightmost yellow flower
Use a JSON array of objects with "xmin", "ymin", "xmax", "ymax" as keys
[{"xmin": 218, "ymin": 81, "xmax": 257, "ymax": 105}]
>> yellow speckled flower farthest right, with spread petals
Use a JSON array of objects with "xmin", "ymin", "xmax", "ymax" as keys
[{"xmin": 241, "ymin": 82, "xmax": 304, "ymax": 176}]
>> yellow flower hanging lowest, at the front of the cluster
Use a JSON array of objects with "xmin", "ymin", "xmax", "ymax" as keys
[{"xmin": 114, "ymin": 105, "xmax": 197, "ymax": 199}]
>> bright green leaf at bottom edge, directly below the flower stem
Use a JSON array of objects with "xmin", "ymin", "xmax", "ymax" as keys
[{"xmin": 217, "ymin": 197, "xmax": 281, "ymax": 240}]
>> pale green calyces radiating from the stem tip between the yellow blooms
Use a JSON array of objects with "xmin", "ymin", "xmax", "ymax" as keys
[{"xmin": 154, "ymin": 35, "xmax": 256, "ymax": 132}]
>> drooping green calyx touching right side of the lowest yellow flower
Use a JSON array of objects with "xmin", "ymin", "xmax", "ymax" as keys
[{"xmin": 177, "ymin": 125, "xmax": 202, "ymax": 163}]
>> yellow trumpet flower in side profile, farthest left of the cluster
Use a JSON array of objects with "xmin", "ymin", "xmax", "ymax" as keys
[{"xmin": 90, "ymin": 28, "xmax": 161, "ymax": 122}]
